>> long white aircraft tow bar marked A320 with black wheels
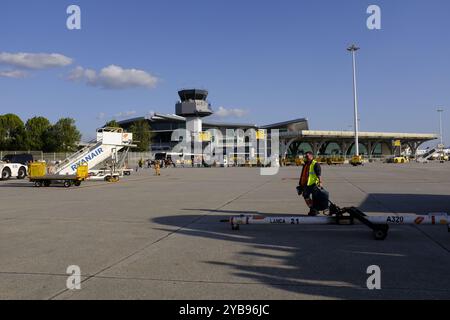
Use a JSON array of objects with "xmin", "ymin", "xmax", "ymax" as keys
[{"xmin": 221, "ymin": 202, "xmax": 450, "ymax": 240}]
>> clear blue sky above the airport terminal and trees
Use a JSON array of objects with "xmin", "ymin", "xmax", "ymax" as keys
[{"xmin": 0, "ymin": 0, "xmax": 450, "ymax": 141}]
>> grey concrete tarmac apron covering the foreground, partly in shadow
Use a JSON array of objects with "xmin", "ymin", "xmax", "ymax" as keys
[{"xmin": 0, "ymin": 163, "xmax": 450, "ymax": 299}]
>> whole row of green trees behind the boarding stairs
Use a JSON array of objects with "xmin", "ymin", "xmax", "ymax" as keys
[{"xmin": 0, "ymin": 113, "xmax": 81, "ymax": 152}]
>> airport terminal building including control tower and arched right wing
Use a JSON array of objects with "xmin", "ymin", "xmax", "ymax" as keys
[{"xmin": 119, "ymin": 89, "xmax": 438, "ymax": 158}]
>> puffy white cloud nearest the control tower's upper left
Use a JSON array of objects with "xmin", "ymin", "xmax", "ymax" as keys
[{"xmin": 69, "ymin": 65, "xmax": 158, "ymax": 89}]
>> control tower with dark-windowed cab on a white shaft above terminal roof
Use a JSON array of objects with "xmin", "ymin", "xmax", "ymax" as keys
[{"xmin": 175, "ymin": 89, "xmax": 213, "ymax": 139}]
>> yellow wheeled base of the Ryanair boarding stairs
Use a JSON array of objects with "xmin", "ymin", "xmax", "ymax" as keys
[{"xmin": 28, "ymin": 162, "xmax": 89, "ymax": 188}]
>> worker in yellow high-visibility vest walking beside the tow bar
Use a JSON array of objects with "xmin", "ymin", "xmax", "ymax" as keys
[{"xmin": 298, "ymin": 152, "xmax": 323, "ymax": 216}]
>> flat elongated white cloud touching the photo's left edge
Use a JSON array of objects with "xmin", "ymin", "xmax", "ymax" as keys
[{"xmin": 0, "ymin": 52, "xmax": 73, "ymax": 69}]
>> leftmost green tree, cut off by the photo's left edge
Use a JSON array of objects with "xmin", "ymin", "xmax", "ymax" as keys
[{"xmin": 0, "ymin": 113, "xmax": 26, "ymax": 151}]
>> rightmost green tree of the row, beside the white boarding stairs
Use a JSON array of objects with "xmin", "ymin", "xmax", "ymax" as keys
[{"xmin": 44, "ymin": 118, "xmax": 81, "ymax": 152}]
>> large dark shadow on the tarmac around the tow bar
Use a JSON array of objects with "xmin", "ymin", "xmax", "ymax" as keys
[{"xmin": 151, "ymin": 194, "xmax": 450, "ymax": 299}]
